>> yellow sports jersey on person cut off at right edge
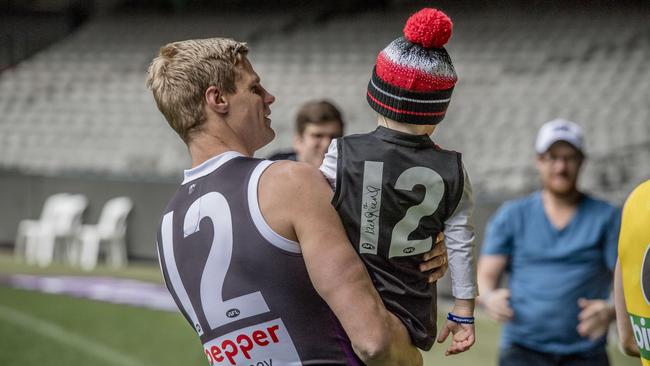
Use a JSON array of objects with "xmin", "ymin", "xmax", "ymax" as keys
[{"xmin": 618, "ymin": 180, "xmax": 650, "ymax": 366}]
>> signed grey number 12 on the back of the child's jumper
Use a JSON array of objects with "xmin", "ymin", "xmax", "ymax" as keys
[{"xmin": 359, "ymin": 161, "xmax": 445, "ymax": 258}]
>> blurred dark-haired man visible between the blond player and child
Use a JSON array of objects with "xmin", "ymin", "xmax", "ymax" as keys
[{"xmin": 269, "ymin": 100, "xmax": 344, "ymax": 168}]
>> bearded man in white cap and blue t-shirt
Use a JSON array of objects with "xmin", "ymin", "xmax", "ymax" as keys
[{"xmin": 478, "ymin": 119, "xmax": 620, "ymax": 366}]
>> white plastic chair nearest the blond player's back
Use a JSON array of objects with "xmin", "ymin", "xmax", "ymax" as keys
[{"xmin": 79, "ymin": 197, "xmax": 133, "ymax": 271}]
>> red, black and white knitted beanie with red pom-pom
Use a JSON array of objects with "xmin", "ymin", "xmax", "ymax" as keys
[{"xmin": 367, "ymin": 8, "xmax": 458, "ymax": 125}]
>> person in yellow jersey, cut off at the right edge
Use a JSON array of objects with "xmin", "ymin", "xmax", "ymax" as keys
[{"xmin": 614, "ymin": 180, "xmax": 650, "ymax": 366}]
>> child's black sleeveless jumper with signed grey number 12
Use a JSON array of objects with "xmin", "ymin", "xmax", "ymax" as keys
[{"xmin": 333, "ymin": 127, "xmax": 464, "ymax": 350}]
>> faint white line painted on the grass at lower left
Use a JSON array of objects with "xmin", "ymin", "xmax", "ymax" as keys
[{"xmin": 0, "ymin": 305, "xmax": 144, "ymax": 366}]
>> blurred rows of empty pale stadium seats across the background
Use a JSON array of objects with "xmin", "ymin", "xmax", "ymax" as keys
[{"xmin": 0, "ymin": 4, "xmax": 650, "ymax": 260}]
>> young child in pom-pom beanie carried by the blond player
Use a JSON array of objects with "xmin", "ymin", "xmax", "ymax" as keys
[{"xmin": 321, "ymin": 8, "xmax": 478, "ymax": 355}]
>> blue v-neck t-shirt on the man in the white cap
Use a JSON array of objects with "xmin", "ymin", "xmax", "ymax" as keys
[{"xmin": 482, "ymin": 192, "xmax": 620, "ymax": 354}]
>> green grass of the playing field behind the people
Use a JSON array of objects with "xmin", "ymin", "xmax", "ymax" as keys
[{"xmin": 0, "ymin": 255, "xmax": 639, "ymax": 366}]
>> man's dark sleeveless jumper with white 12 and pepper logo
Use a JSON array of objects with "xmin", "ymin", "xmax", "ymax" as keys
[{"xmin": 157, "ymin": 152, "xmax": 362, "ymax": 366}]
